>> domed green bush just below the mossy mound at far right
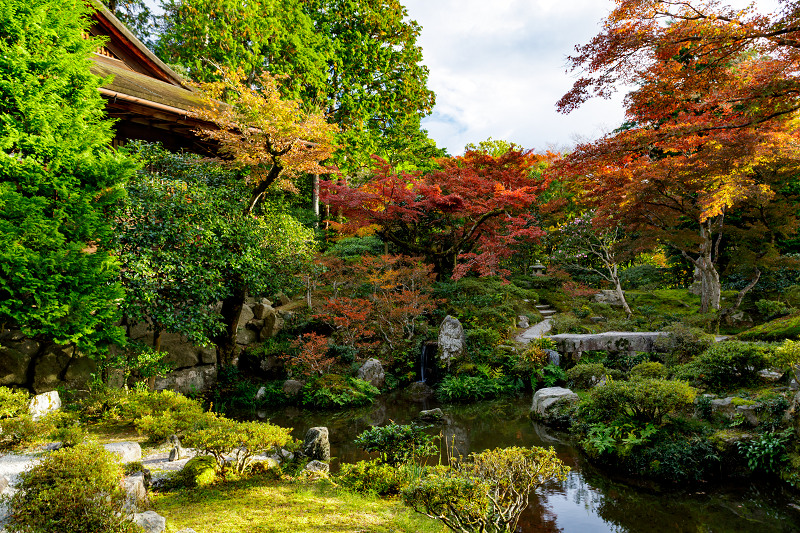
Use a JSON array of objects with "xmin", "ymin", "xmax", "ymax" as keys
[{"xmin": 676, "ymin": 341, "xmax": 773, "ymax": 391}]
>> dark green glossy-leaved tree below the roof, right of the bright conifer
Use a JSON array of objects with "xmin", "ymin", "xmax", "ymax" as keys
[{"xmin": 116, "ymin": 145, "xmax": 314, "ymax": 364}]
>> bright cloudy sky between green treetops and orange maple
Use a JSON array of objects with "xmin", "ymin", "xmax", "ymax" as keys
[{"xmin": 403, "ymin": 0, "xmax": 622, "ymax": 155}]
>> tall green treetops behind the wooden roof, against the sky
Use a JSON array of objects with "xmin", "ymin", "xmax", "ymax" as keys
[{"xmin": 157, "ymin": 0, "xmax": 444, "ymax": 173}]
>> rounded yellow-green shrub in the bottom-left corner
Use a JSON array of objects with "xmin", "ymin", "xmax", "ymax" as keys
[{"xmin": 6, "ymin": 444, "xmax": 141, "ymax": 533}]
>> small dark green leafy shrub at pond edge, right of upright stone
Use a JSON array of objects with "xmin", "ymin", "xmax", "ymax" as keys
[{"xmin": 355, "ymin": 422, "xmax": 439, "ymax": 466}]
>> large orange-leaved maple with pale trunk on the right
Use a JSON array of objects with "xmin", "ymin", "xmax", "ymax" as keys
[{"xmin": 557, "ymin": 0, "xmax": 800, "ymax": 312}]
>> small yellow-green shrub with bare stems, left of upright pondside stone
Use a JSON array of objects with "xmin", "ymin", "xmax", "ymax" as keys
[{"xmin": 183, "ymin": 413, "xmax": 291, "ymax": 474}]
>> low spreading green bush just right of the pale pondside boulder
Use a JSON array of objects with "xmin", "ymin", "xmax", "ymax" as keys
[{"xmin": 578, "ymin": 378, "xmax": 697, "ymax": 424}]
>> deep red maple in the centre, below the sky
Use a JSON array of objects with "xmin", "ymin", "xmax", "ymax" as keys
[{"xmin": 322, "ymin": 149, "xmax": 546, "ymax": 279}]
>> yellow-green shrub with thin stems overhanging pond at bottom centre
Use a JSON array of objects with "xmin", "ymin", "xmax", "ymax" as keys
[{"xmin": 403, "ymin": 447, "xmax": 569, "ymax": 532}]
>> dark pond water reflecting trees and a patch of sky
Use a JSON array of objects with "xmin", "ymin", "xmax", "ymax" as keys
[{"xmin": 260, "ymin": 394, "xmax": 800, "ymax": 533}]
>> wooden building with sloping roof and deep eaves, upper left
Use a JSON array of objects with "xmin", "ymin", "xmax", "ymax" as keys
[{"xmin": 91, "ymin": 0, "xmax": 215, "ymax": 155}]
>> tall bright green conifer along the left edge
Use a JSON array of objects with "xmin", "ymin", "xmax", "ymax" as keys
[{"xmin": 0, "ymin": 0, "xmax": 133, "ymax": 353}]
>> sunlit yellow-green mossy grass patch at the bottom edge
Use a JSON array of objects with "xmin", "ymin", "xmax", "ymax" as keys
[{"xmin": 152, "ymin": 476, "xmax": 445, "ymax": 533}]
